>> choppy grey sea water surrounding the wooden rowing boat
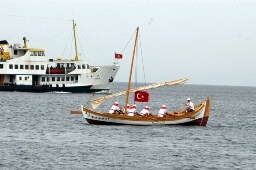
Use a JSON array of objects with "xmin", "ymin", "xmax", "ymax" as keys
[{"xmin": 0, "ymin": 83, "xmax": 256, "ymax": 170}]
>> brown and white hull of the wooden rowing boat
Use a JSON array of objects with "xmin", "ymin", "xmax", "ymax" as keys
[{"xmin": 81, "ymin": 99, "xmax": 210, "ymax": 126}]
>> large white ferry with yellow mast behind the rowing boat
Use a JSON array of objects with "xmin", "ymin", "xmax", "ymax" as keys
[{"xmin": 0, "ymin": 20, "xmax": 120, "ymax": 93}]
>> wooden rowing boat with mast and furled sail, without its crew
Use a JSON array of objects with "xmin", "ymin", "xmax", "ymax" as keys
[{"xmin": 71, "ymin": 28, "xmax": 210, "ymax": 126}]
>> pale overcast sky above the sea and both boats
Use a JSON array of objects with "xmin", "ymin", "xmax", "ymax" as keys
[{"xmin": 0, "ymin": 0, "xmax": 256, "ymax": 86}]
